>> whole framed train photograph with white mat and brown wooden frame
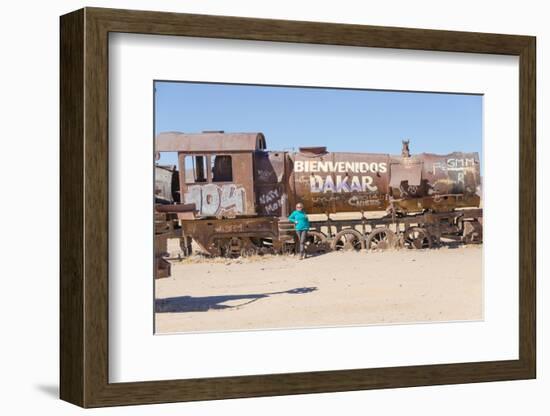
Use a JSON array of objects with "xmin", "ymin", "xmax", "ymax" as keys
[{"xmin": 60, "ymin": 8, "xmax": 536, "ymax": 407}]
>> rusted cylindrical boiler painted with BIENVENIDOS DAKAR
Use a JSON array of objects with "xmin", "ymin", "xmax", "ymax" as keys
[{"xmin": 289, "ymin": 148, "xmax": 480, "ymax": 214}]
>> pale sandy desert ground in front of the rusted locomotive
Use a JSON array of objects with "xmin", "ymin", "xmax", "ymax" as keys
[{"xmin": 155, "ymin": 246, "xmax": 483, "ymax": 333}]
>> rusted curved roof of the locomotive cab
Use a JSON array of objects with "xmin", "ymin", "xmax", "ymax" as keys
[{"xmin": 155, "ymin": 132, "xmax": 266, "ymax": 153}]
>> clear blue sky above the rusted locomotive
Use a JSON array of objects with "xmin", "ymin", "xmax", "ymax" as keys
[{"xmin": 155, "ymin": 81, "xmax": 483, "ymax": 164}]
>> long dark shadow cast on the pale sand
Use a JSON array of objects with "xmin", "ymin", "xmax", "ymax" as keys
[{"xmin": 155, "ymin": 287, "xmax": 317, "ymax": 313}]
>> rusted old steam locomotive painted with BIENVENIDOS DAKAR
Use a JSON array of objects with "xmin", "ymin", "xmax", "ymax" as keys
[{"xmin": 156, "ymin": 132, "xmax": 482, "ymax": 255}]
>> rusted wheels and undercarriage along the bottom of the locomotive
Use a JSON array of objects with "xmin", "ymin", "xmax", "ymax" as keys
[{"xmin": 177, "ymin": 208, "xmax": 483, "ymax": 257}]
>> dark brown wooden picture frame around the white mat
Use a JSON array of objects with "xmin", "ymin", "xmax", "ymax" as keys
[{"xmin": 60, "ymin": 8, "xmax": 536, "ymax": 407}]
